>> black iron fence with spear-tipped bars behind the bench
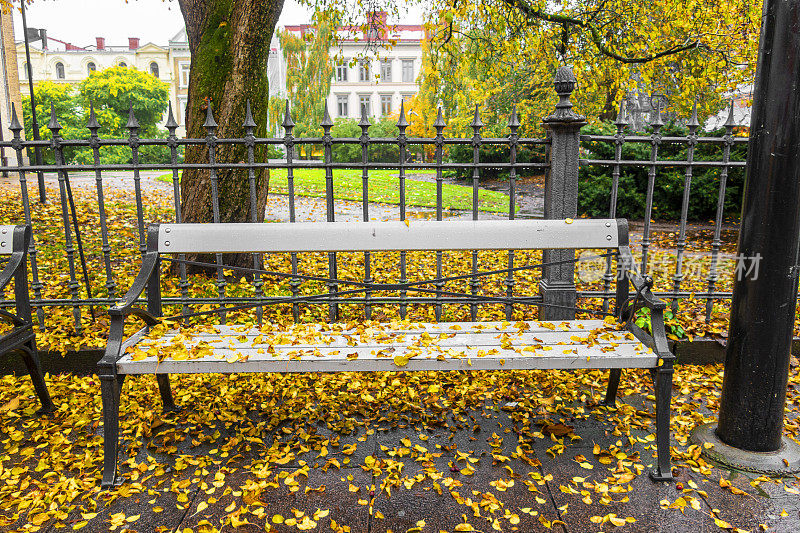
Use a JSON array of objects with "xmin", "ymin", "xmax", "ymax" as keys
[{"xmin": 0, "ymin": 67, "xmax": 747, "ymax": 331}]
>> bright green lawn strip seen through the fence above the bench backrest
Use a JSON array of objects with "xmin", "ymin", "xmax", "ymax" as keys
[{"xmin": 158, "ymin": 168, "xmax": 508, "ymax": 213}]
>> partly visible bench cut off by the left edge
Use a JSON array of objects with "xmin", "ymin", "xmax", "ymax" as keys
[{"xmin": 0, "ymin": 222, "xmax": 54, "ymax": 414}]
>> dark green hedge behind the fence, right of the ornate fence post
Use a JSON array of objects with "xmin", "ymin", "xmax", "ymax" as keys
[{"xmin": 578, "ymin": 123, "xmax": 747, "ymax": 220}]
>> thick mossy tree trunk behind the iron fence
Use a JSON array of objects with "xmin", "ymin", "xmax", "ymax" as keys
[{"xmin": 179, "ymin": 0, "xmax": 283, "ymax": 267}]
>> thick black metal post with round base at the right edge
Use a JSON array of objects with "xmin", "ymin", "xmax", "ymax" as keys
[{"xmin": 694, "ymin": 0, "xmax": 800, "ymax": 475}]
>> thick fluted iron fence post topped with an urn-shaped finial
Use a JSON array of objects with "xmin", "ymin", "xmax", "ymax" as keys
[{"xmin": 539, "ymin": 66, "xmax": 586, "ymax": 320}]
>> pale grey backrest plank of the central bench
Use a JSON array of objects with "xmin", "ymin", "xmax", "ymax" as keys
[{"xmin": 150, "ymin": 219, "xmax": 628, "ymax": 253}]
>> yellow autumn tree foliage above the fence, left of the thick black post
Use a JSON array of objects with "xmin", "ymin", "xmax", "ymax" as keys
[{"xmin": 412, "ymin": 0, "xmax": 761, "ymax": 134}]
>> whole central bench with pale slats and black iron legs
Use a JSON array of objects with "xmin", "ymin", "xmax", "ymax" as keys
[{"xmin": 98, "ymin": 219, "xmax": 673, "ymax": 487}]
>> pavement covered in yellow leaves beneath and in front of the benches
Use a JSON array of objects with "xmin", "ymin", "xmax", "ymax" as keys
[{"xmin": 0, "ymin": 365, "xmax": 800, "ymax": 533}]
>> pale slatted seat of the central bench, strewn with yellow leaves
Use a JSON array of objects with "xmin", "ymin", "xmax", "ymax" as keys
[{"xmin": 117, "ymin": 320, "xmax": 658, "ymax": 374}]
